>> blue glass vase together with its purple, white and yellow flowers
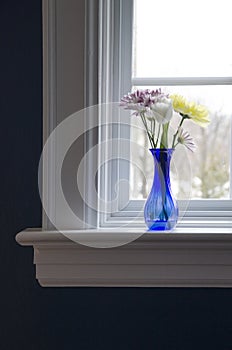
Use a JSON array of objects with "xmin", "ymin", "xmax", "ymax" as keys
[{"xmin": 120, "ymin": 89, "xmax": 209, "ymax": 231}]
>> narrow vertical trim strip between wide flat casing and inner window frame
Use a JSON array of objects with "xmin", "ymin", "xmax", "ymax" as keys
[{"xmin": 83, "ymin": 0, "xmax": 99, "ymax": 228}]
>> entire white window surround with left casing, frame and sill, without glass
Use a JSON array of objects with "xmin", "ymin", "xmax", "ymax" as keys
[{"xmin": 16, "ymin": 0, "xmax": 232, "ymax": 287}]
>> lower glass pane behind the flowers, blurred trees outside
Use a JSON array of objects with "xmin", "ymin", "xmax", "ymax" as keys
[{"xmin": 130, "ymin": 86, "xmax": 232, "ymax": 199}]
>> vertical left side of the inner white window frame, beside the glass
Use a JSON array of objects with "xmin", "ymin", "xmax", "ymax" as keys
[{"xmin": 98, "ymin": 0, "xmax": 133, "ymax": 226}]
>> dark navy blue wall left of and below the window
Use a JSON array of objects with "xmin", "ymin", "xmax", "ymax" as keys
[{"xmin": 0, "ymin": 0, "xmax": 232, "ymax": 350}]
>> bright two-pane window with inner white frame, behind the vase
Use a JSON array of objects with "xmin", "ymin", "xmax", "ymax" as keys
[{"xmin": 97, "ymin": 0, "xmax": 232, "ymax": 226}]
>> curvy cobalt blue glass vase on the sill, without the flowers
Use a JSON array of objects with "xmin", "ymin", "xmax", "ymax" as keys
[{"xmin": 144, "ymin": 148, "xmax": 178, "ymax": 231}]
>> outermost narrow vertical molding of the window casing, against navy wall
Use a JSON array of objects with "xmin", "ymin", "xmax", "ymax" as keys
[{"xmin": 39, "ymin": 0, "xmax": 57, "ymax": 229}]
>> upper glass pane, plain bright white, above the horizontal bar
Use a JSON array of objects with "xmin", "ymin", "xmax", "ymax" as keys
[{"xmin": 133, "ymin": 0, "xmax": 232, "ymax": 77}]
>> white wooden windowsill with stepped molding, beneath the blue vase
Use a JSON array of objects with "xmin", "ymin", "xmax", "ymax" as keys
[{"xmin": 16, "ymin": 228, "xmax": 232, "ymax": 287}]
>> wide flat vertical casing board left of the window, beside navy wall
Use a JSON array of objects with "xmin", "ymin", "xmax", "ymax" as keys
[{"xmin": 39, "ymin": 0, "xmax": 87, "ymax": 229}]
